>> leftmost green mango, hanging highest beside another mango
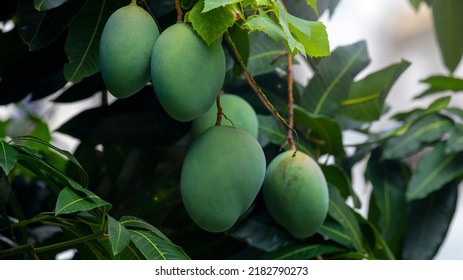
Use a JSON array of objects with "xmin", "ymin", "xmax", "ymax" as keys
[{"xmin": 99, "ymin": 3, "xmax": 159, "ymax": 98}]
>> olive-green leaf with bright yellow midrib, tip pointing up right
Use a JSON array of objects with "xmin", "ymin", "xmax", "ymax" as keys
[{"xmin": 340, "ymin": 61, "xmax": 410, "ymax": 122}]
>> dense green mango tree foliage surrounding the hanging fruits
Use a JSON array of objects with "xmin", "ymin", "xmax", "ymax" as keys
[{"xmin": 0, "ymin": 0, "xmax": 463, "ymax": 259}]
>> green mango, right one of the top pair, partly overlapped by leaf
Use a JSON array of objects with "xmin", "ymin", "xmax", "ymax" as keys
[{"xmin": 151, "ymin": 23, "xmax": 226, "ymax": 122}]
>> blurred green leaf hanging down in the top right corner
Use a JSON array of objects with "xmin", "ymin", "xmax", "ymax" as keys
[{"xmin": 432, "ymin": 0, "xmax": 463, "ymax": 73}]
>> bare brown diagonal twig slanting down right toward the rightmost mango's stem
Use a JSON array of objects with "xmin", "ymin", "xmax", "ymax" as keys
[{"xmin": 224, "ymin": 31, "xmax": 296, "ymax": 137}]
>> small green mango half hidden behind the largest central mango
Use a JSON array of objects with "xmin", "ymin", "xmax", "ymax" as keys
[{"xmin": 191, "ymin": 94, "xmax": 259, "ymax": 139}]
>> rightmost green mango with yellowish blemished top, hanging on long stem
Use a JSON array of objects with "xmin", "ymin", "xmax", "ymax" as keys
[{"xmin": 262, "ymin": 151, "xmax": 329, "ymax": 238}]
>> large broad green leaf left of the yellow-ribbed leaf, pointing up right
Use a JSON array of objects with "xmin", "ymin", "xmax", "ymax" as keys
[{"xmin": 300, "ymin": 41, "xmax": 370, "ymax": 116}]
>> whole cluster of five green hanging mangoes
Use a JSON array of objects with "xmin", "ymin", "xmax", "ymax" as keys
[{"xmin": 99, "ymin": 1, "xmax": 329, "ymax": 238}]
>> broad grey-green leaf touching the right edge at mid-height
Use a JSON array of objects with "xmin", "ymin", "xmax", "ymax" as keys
[{"xmin": 406, "ymin": 142, "xmax": 463, "ymax": 201}]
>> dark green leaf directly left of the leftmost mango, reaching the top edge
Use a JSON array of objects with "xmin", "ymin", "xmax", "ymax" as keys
[{"xmin": 63, "ymin": 0, "xmax": 118, "ymax": 83}]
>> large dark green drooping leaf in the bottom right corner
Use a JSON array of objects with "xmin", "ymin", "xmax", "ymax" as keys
[{"xmin": 402, "ymin": 182, "xmax": 458, "ymax": 260}]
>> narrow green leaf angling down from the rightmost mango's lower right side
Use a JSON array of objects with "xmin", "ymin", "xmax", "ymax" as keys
[{"xmin": 328, "ymin": 185, "xmax": 364, "ymax": 252}]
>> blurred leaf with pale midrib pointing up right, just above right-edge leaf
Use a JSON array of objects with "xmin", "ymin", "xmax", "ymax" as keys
[{"xmin": 383, "ymin": 114, "xmax": 453, "ymax": 159}]
